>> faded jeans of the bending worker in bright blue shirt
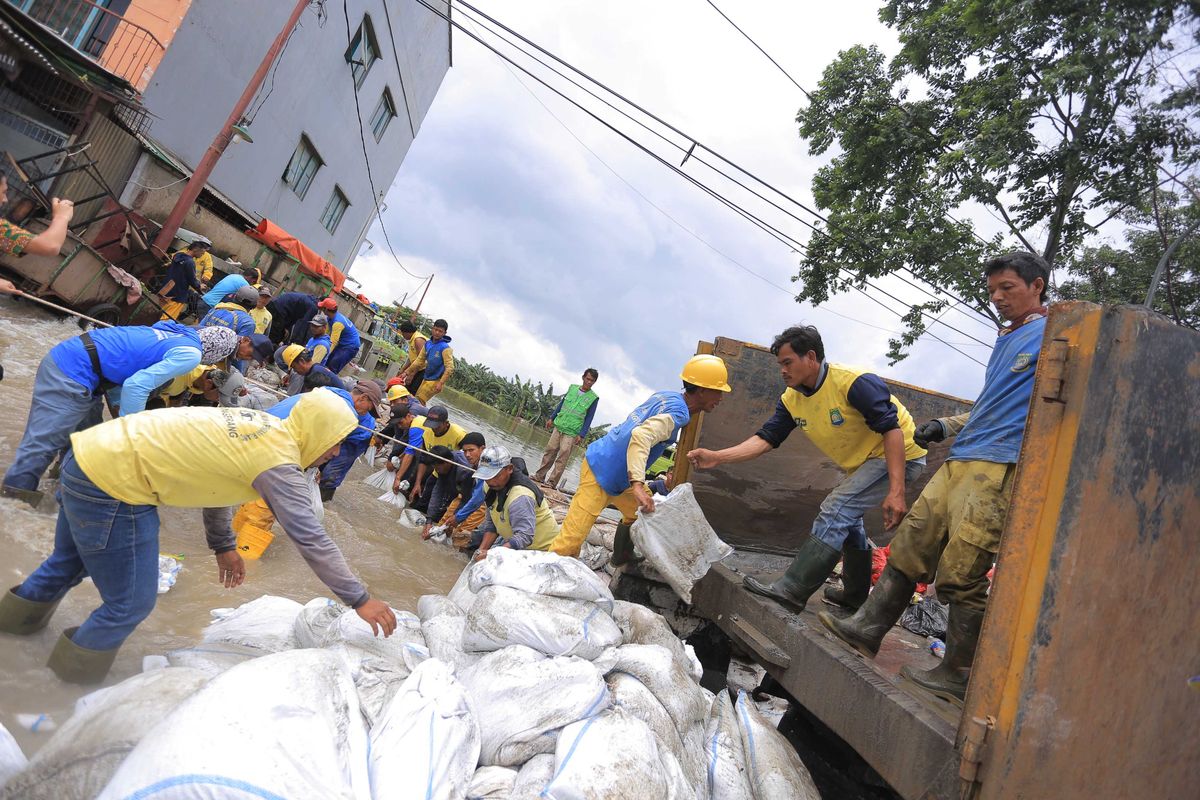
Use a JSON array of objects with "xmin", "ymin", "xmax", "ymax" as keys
[{"xmin": 4, "ymin": 355, "xmax": 104, "ymax": 492}]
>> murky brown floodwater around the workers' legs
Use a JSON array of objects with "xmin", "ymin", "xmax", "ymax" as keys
[{"xmin": 0, "ymin": 297, "xmax": 580, "ymax": 756}]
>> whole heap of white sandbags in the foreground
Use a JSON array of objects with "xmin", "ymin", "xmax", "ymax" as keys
[{"xmin": 0, "ymin": 548, "xmax": 820, "ymax": 800}]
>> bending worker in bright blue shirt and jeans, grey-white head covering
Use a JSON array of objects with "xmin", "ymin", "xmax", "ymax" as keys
[{"xmin": 4, "ymin": 320, "xmax": 239, "ymax": 506}]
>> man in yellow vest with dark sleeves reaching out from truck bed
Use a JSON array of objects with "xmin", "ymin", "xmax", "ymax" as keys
[{"xmin": 688, "ymin": 325, "xmax": 925, "ymax": 612}]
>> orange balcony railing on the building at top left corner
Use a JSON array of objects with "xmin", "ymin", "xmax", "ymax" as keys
[{"xmin": 7, "ymin": 0, "xmax": 167, "ymax": 91}]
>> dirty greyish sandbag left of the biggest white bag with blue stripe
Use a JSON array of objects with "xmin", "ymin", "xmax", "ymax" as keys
[{"xmin": 0, "ymin": 667, "xmax": 210, "ymax": 800}]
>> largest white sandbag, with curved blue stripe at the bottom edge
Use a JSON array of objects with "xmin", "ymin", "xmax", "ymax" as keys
[{"xmin": 100, "ymin": 652, "xmax": 371, "ymax": 800}]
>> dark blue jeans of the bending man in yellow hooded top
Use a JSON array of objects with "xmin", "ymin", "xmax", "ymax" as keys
[{"xmin": 16, "ymin": 452, "xmax": 158, "ymax": 650}]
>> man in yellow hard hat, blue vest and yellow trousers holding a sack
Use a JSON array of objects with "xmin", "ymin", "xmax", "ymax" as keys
[{"xmin": 550, "ymin": 355, "xmax": 730, "ymax": 566}]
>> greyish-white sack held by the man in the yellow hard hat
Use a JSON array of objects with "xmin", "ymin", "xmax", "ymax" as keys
[{"xmin": 630, "ymin": 483, "xmax": 733, "ymax": 603}]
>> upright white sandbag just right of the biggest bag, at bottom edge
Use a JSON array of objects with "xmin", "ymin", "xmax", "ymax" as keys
[{"xmin": 367, "ymin": 658, "xmax": 479, "ymax": 800}]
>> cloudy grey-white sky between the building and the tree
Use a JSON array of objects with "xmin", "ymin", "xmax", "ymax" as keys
[{"xmin": 350, "ymin": 0, "xmax": 994, "ymax": 422}]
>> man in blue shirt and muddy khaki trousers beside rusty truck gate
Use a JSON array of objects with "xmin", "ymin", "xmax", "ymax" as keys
[{"xmin": 820, "ymin": 252, "xmax": 1050, "ymax": 706}]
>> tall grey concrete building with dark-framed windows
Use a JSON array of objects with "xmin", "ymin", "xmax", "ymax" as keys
[{"xmin": 139, "ymin": 0, "xmax": 450, "ymax": 270}]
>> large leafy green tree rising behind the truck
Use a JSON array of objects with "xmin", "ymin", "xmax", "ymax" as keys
[{"xmin": 797, "ymin": 0, "xmax": 1200, "ymax": 360}]
